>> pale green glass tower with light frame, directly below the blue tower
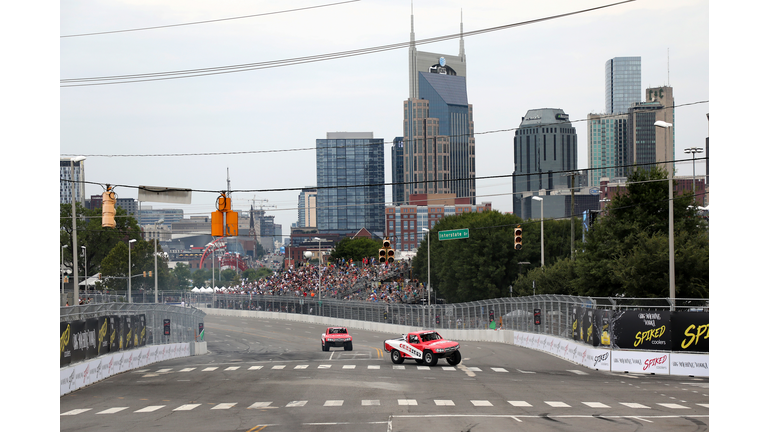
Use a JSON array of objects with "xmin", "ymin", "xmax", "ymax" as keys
[{"xmin": 587, "ymin": 114, "xmax": 629, "ymax": 187}]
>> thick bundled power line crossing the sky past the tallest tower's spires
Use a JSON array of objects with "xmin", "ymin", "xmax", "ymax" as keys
[{"xmin": 60, "ymin": 0, "xmax": 635, "ymax": 87}]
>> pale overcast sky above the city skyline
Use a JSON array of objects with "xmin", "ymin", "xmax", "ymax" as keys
[{"xmin": 55, "ymin": 0, "xmax": 709, "ymax": 240}]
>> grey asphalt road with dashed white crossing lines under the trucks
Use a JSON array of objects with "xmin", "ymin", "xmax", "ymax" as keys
[{"xmin": 60, "ymin": 315, "xmax": 710, "ymax": 432}]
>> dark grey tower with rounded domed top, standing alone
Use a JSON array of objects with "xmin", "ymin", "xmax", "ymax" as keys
[{"xmin": 512, "ymin": 108, "xmax": 578, "ymax": 217}]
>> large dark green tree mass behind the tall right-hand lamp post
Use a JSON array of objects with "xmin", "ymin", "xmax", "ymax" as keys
[{"xmin": 574, "ymin": 167, "xmax": 709, "ymax": 298}]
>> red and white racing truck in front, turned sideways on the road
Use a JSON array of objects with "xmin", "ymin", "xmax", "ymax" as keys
[{"xmin": 384, "ymin": 330, "xmax": 461, "ymax": 366}]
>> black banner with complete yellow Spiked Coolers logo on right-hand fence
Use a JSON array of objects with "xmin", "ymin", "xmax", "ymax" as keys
[{"xmin": 611, "ymin": 311, "xmax": 672, "ymax": 351}]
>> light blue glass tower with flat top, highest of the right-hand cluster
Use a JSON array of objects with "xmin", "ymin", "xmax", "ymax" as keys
[{"xmin": 605, "ymin": 57, "xmax": 642, "ymax": 114}]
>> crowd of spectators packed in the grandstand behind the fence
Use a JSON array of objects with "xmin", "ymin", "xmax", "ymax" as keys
[{"xmin": 210, "ymin": 259, "xmax": 426, "ymax": 303}]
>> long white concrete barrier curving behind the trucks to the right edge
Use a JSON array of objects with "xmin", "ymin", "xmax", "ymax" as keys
[{"xmin": 206, "ymin": 309, "xmax": 709, "ymax": 377}]
